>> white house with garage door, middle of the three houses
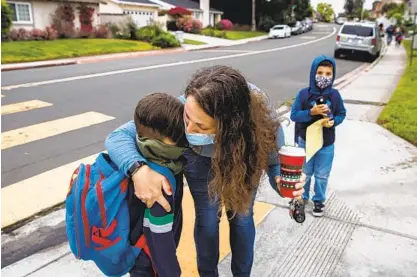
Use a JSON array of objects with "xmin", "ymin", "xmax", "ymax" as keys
[{"xmin": 100, "ymin": 0, "xmax": 160, "ymax": 27}]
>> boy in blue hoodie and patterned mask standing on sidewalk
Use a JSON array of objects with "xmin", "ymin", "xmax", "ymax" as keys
[{"xmin": 291, "ymin": 55, "xmax": 346, "ymax": 217}]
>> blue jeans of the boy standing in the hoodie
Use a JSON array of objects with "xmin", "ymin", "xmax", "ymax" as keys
[{"xmin": 298, "ymin": 138, "xmax": 334, "ymax": 203}]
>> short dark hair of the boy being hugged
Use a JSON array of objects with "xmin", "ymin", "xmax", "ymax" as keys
[{"xmin": 134, "ymin": 93, "xmax": 187, "ymax": 147}]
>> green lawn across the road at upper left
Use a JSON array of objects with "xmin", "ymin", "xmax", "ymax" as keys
[{"xmin": 1, "ymin": 39, "xmax": 159, "ymax": 64}]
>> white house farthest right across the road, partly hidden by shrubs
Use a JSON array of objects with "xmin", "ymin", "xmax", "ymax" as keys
[{"xmin": 149, "ymin": 0, "xmax": 223, "ymax": 27}]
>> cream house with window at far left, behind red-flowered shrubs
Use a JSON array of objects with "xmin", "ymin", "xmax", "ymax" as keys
[{"xmin": 6, "ymin": 0, "xmax": 102, "ymax": 30}]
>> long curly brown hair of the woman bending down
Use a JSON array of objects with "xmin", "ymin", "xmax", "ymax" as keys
[{"xmin": 185, "ymin": 66, "xmax": 279, "ymax": 214}]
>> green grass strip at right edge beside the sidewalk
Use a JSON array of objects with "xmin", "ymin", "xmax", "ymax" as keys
[{"xmin": 378, "ymin": 40, "xmax": 417, "ymax": 146}]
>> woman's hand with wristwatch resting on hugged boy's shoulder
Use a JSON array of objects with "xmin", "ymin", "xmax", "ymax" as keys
[{"xmin": 132, "ymin": 165, "xmax": 172, "ymax": 212}]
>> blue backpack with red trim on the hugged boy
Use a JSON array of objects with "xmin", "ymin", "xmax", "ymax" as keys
[{"xmin": 65, "ymin": 153, "xmax": 176, "ymax": 276}]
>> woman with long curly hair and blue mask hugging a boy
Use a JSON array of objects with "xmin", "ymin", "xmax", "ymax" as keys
[{"xmin": 106, "ymin": 66, "xmax": 303, "ymax": 277}]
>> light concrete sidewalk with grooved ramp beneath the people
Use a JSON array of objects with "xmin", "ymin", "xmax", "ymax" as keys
[{"xmin": 1, "ymin": 47, "xmax": 417, "ymax": 277}]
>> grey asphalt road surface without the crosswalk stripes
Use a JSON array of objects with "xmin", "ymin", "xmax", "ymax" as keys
[{"xmin": 1, "ymin": 25, "xmax": 362, "ymax": 267}]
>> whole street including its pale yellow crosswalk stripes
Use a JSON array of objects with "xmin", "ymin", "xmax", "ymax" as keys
[{"xmin": 1, "ymin": 24, "xmax": 363, "ymax": 272}]
